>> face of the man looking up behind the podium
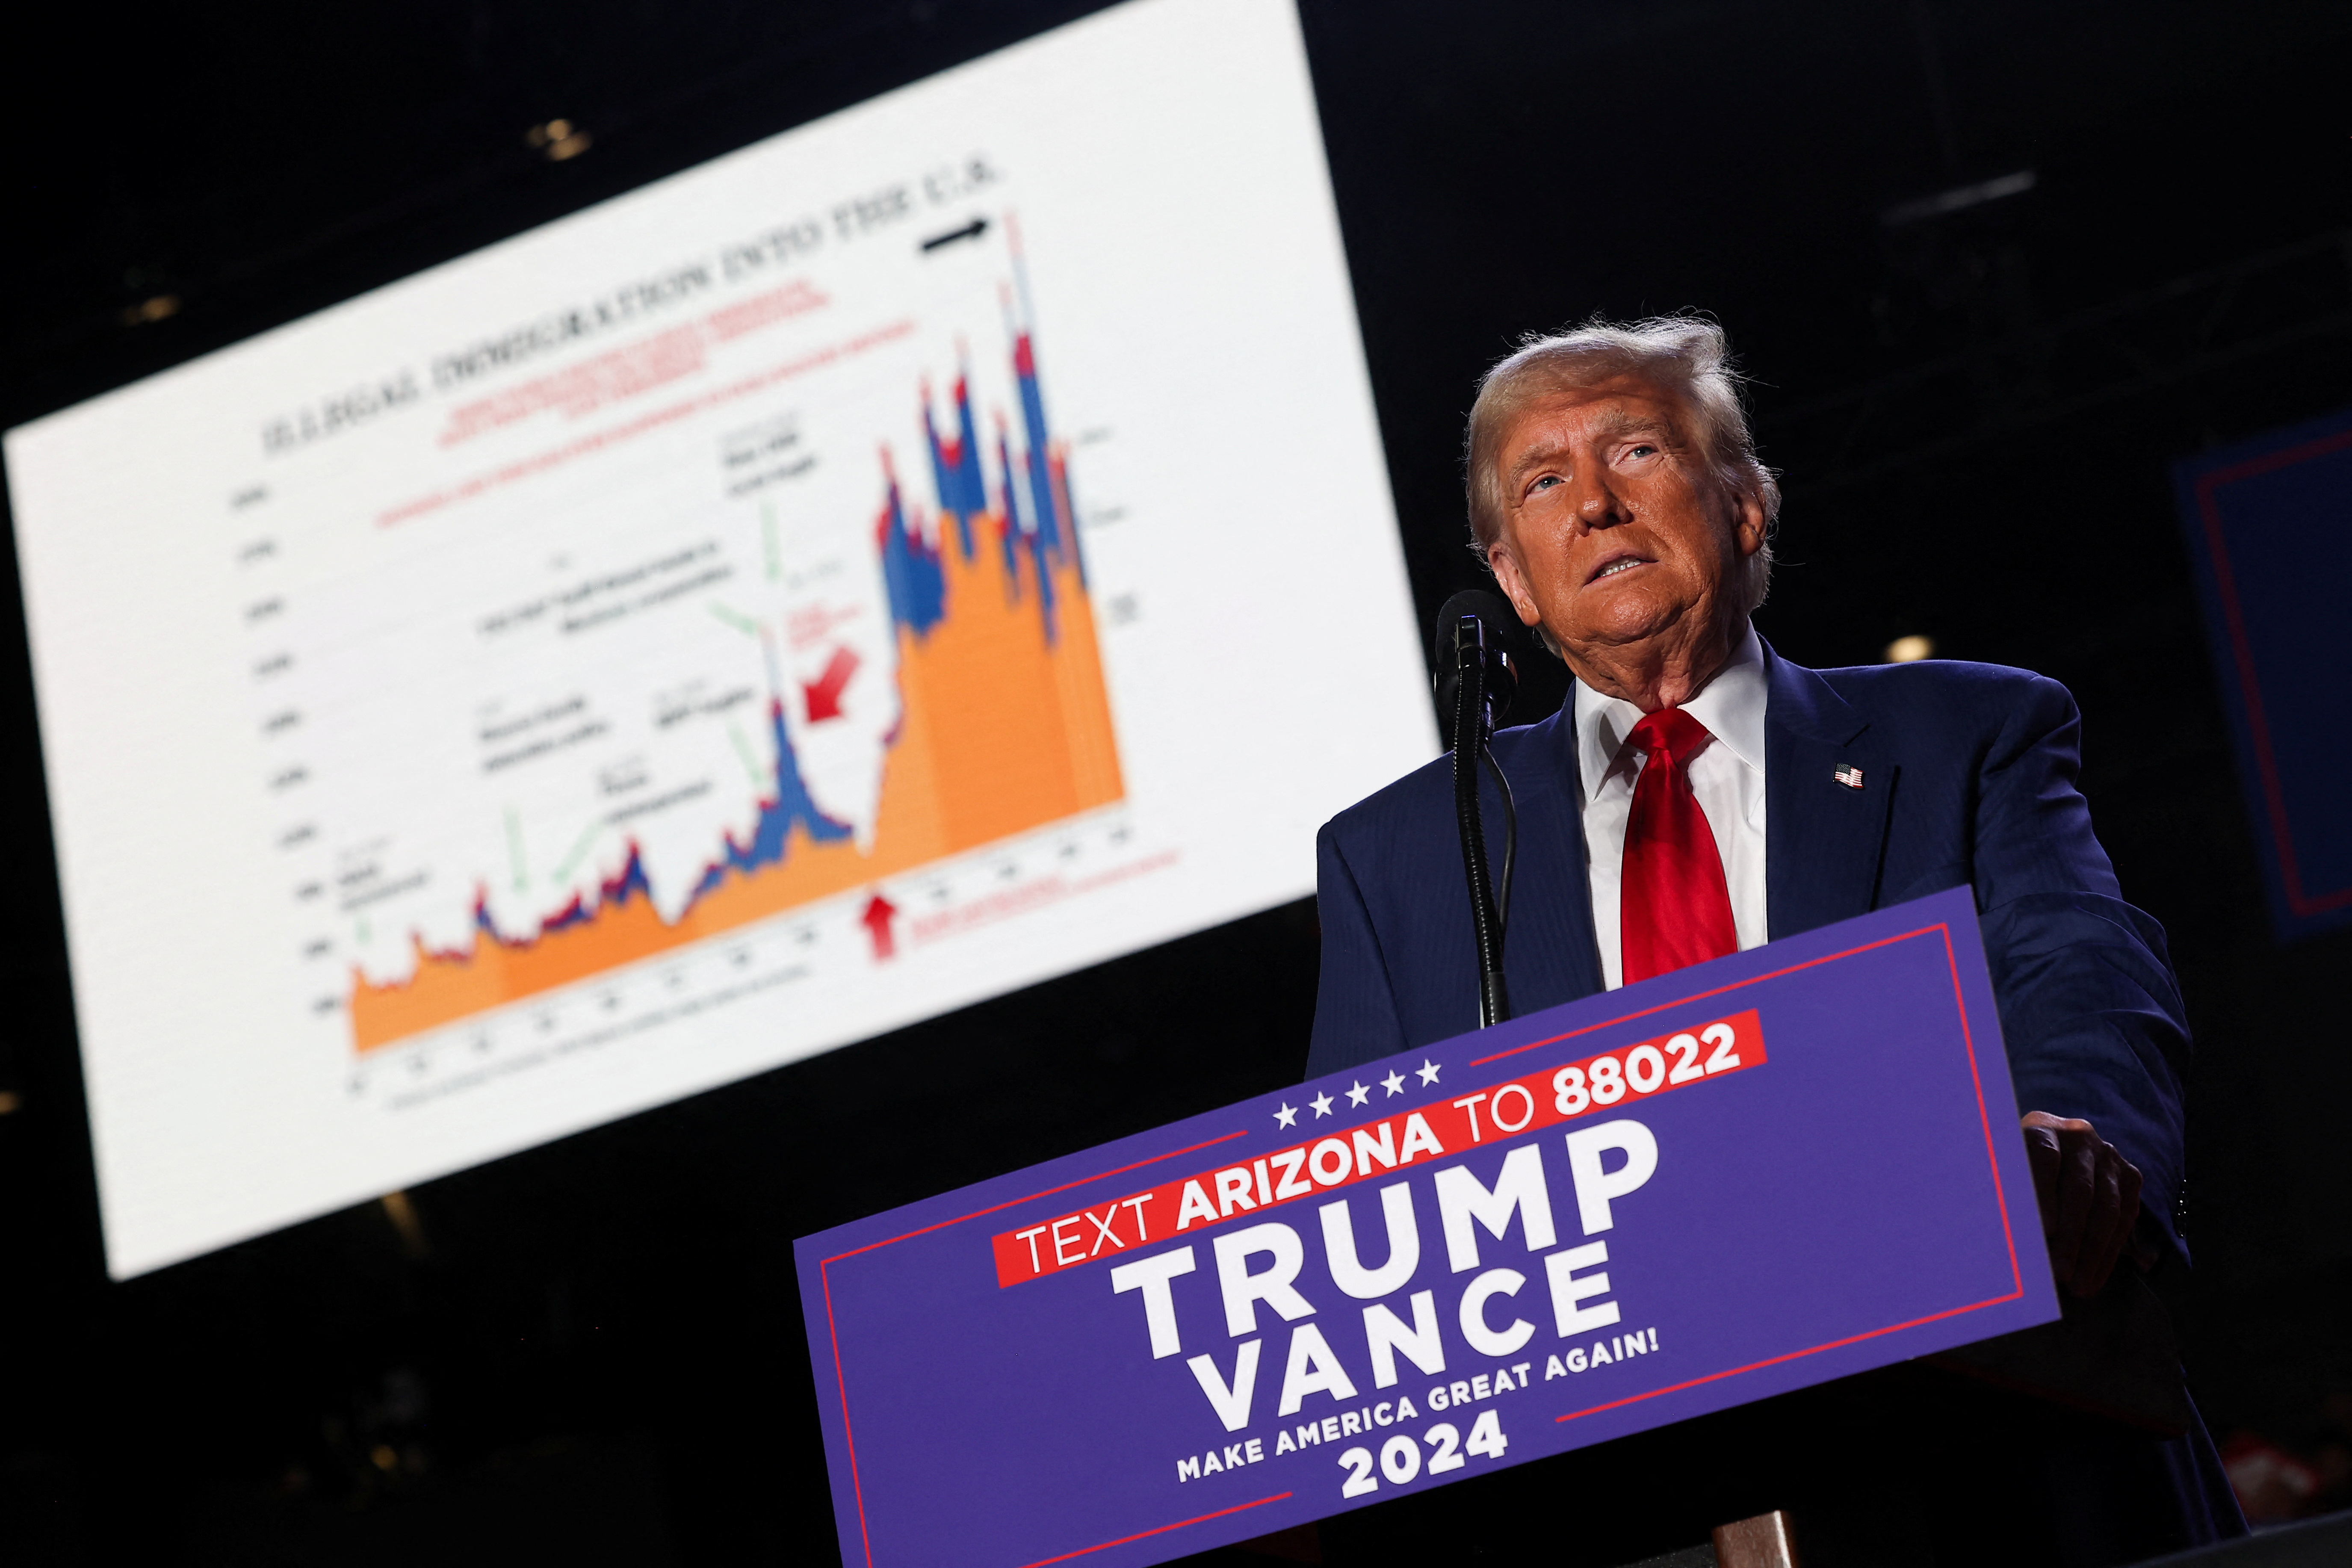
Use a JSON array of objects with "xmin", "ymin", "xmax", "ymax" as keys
[{"xmin": 1489, "ymin": 376, "xmax": 1764, "ymax": 672}]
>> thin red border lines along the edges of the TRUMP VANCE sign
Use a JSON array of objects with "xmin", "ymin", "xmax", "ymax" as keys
[{"xmin": 816, "ymin": 921, "xmax": 2025, "ymax": 1568}]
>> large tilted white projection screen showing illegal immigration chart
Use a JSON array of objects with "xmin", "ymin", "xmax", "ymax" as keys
[{"xmin": 5, "ymin": 0, "xmax": 1437, "ymax": 1276}]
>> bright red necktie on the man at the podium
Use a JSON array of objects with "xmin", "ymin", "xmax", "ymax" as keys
[{"xmin": 1618, "ymin": 708, "xmax": 1740, "ymax": 985}]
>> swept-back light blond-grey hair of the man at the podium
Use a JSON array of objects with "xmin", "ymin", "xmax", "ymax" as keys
[{"xmin": 1463, "ymin": 315, "xmax": 1781, "ymax": 614}]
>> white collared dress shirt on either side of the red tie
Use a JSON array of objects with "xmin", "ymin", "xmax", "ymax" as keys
[{"xmin": 1576, "ymin": 628, "xmax": 1771, "ymax": 990}]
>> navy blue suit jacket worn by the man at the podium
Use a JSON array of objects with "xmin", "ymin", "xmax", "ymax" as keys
[{"xmin": 1308, "ymin": 647, "xmax": 2190, "ymax": 1243}]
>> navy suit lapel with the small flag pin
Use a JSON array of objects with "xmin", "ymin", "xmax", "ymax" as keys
[{"xmin": 1764, "ymin": 644, "xmax": 1900, "ymax": 938}]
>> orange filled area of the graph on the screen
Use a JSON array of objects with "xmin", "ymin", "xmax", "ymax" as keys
[{"xmin": 351, "ymin": 503, "xmax": 1124, "ymax": 1053}]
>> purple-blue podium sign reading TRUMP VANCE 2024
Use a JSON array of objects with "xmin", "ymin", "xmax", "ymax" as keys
[{"xmin": 798, "ymin": 889, "xmax": 2058, "ymax": 1568}]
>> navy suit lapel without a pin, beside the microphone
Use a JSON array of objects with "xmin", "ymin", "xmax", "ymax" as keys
[{"xmin": 1484, "ymin": 710, "xmax": 1609, "ymax": 1013}]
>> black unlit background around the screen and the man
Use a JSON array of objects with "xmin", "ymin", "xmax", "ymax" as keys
[{"xmin": 0, "ymin": 0, "xmax": 2352, "ymax": 1563}]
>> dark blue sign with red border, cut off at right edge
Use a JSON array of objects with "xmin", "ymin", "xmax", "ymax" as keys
[{"xmin": 2173, "ymin": 411, "xmax": 2352, "ymax": 938}]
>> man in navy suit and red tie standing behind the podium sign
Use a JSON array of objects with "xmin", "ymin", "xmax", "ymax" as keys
[{"xmin": 1308, "ymin": 317, "xmax": 2244, "ymax": 1563}]
